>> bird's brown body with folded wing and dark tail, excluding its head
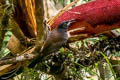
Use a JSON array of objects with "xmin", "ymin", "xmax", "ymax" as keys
[{"xmin": 29, "ymin": 30, "xmax": 67, "ymax": 67}]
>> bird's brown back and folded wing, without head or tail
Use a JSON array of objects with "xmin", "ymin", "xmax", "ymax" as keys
[{"xmin": 40, "ymin": 30, "xmax": 67, "ymax": 56}]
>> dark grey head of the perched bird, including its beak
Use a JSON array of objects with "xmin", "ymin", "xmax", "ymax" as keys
[{"xmin": 57, "ymin": 19, "xmax": 75, "ymax": 31}]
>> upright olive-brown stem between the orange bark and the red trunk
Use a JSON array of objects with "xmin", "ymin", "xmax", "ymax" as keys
[{"xmin": 35, "ymin": 0, "xmax": 44, "ymax": 42}]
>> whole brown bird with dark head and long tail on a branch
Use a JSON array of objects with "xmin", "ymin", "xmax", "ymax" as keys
[{"xmin": 28, "ymin": 19, "xmax": 75, "ymax": 68}]
